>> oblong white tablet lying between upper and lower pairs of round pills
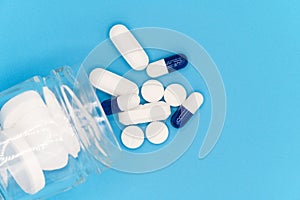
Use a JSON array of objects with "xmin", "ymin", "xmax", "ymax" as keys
[{"xmin": 118, "ymin": 101, "xmax": 171, "ymax": 125}]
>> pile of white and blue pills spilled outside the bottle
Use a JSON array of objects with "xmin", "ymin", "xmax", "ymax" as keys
[{"xmin": 89, "ymin": 24, "xmax": 203, "ymax": 149}]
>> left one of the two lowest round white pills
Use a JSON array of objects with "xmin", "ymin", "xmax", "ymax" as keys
[{"xmin": 121, "ymin": 126, "xmax": 145, "ymax": 149}]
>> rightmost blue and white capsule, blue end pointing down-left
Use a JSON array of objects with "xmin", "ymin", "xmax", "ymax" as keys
[{"xmin": 171, "ymin": 92, "xmax": 204, "ymax": 128}]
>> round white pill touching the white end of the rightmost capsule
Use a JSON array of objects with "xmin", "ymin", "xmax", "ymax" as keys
[{"xmin": 164, "ymin": 84, "xmax": 186, "ymax": 107}]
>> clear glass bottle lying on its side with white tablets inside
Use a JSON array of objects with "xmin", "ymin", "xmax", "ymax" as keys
[{"xmin": 0, "ymin": 67, "xmax": 120, "ymax": 200}]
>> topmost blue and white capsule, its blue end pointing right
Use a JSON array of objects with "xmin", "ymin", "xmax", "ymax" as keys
[{"xmin": 147, "ymin": 54, "xmax": 188, "ymax": 78}]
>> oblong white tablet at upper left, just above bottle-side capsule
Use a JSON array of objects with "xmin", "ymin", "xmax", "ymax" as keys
[{"xmin": 89, "ymin": 68, "xmax": 139, "ymax": 96}]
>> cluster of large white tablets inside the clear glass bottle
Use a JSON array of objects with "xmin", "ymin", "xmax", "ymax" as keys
[{"xmin": 0, "ymin": 86, "xmax": 81, "ymax": 194}]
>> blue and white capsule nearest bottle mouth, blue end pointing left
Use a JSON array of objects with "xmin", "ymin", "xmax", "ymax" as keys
[{"xmin": 101, "ymin": 94, "xmax": 140, "ymax": 115}]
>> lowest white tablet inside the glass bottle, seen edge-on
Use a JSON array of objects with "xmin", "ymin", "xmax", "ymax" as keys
[{"xmin": 0, "ymin": 129, "xmax": 45, "ymax": 194}]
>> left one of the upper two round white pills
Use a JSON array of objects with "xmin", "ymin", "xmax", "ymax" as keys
[{"xmin": 141, "ymin": 80, "xmax": 164, "ymax": 102}]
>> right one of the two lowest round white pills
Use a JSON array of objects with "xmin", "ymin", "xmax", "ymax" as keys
[{"xmin": 146, "ymin": 122, "xmax": 169, "ymax": 144}]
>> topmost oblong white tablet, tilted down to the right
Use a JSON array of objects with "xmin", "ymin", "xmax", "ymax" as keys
[{"xmin": 109, "ymin": 24, "xmax": 149, "ymax": 70}]
